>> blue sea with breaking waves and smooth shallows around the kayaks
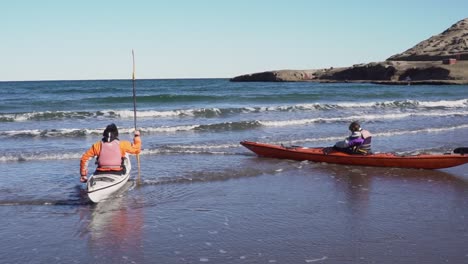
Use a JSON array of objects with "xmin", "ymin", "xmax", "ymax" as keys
[{"xmin": 0, "ymin": 79, "xmax": 468, "ymax": 263}]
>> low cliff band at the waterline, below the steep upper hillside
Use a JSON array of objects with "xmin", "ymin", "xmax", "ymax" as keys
[{"xmin": 229, "ymin": 61, "xmax": 468, "ymax": 85}]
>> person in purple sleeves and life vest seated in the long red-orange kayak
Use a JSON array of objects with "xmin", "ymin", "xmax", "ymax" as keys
[{"xmin": 333, "ymin": 121, "xmax": 372, "ymax": 155}]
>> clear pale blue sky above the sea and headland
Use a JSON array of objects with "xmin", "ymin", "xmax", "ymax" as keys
[{"xmin": 0, "ymin": 0, "xmax": 468, "ymax": 81}]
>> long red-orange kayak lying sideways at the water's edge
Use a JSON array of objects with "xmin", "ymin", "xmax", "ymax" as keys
[{"xmin": 240, "ymin": 141, "xmax": 468, "ymax": 169}]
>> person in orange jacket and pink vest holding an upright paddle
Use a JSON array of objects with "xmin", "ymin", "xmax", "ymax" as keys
[{"xmin": 80, "ymin": 124, "xmax": 141, "ymax": 183}]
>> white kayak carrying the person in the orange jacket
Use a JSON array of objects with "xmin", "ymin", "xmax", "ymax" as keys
[{"xmin": 86, "ymin": 155, "xmax": 132, "ymax": 203}]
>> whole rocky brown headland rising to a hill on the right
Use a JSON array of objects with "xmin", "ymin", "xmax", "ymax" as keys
[{"xmin": 231, "ymin": 18, "xmax": 468, "ymax": 84}]
